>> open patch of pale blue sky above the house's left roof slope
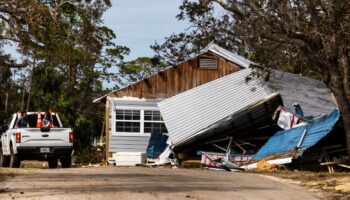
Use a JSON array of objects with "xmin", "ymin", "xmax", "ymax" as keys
[{"xmin": 104, "ymin": 0, "xmax": 188, "ymax": 61}]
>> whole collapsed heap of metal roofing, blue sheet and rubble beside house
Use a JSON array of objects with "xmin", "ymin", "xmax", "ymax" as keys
[{"xmin": 104, "ymin": 69, "xmax": 349, "ymax": 173}]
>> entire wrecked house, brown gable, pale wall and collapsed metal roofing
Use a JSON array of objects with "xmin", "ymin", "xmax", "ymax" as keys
[{"xmin": 94, "ymin": 43, "xmax": 344, "ymax": 166}]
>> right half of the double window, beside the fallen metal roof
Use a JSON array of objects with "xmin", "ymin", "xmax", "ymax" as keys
[{"xmin": 144, "ymin": 110, "xmax": 168, "ymax": 133}]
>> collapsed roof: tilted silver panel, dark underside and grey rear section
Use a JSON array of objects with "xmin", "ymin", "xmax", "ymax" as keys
[{"xmin": 158, "ymin": 69, "xmax": 336, "ymax": 168}]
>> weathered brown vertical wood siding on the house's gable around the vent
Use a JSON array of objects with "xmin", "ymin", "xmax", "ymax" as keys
[{"xmin": 116, "ymin": 52, "xmax": 240, "ymax": 99}]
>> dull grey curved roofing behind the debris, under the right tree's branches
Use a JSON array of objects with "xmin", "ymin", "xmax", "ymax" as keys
[{"xmin": 264, "ymin": 70, "xmax": 336, "ymax": 116}]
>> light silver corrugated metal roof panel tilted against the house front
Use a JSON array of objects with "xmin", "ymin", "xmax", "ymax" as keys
[{"xmin": 158, "ymin": 69, "xmax": 268, "ymax": 145}]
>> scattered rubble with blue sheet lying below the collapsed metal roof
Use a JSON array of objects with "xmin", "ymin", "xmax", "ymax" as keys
[{"xmin": 145, "ymin": 104, "xmax": 350, "ymax": 173}]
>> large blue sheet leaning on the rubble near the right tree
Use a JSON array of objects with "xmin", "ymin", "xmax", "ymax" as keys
[{"xmin": 254, "ymin": 109, "xmax": 340, "ymax": 160}]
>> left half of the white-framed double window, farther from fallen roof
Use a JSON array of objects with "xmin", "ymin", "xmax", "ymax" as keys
[{"xmin": 115, "ymin": 109, "xmax": 141, "ymax": 133}]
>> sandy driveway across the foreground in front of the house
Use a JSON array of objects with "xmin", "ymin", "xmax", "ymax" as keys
[{"xmin": 0, "ymin": 167, "xmax": 317, "ymax": 200}]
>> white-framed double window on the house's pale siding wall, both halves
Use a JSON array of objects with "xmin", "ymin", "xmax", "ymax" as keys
[{"xmin": 115, "ymin": 109, "xmax": 168, "ymax": 133}]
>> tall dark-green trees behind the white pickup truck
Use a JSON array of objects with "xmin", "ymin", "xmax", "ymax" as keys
[{"xmin": 0, "ymin": 0, "xmax": 129, "ymax": 162}]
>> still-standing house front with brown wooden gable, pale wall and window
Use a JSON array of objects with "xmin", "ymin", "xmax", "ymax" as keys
[{"xmin": 94, "ymin": 43, "xmax": 250, "ymax": 165}]
